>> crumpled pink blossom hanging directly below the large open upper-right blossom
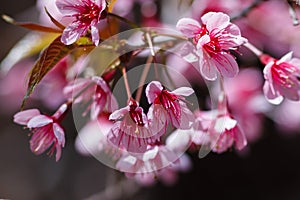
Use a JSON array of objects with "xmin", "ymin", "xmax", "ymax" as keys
[{"xmin": 184, "ymin": 94, "xmax": 247, "ymax": 153}]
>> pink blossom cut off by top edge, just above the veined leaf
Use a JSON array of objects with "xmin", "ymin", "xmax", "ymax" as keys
[{"xmin": 56, "ymin": 0, "xmax": 106, "ymax": 46}]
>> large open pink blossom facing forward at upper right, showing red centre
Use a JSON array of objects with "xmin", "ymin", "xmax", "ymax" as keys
[{"xmin": 177, "ymin": 12, "xmax": 247, "ymax": 80}]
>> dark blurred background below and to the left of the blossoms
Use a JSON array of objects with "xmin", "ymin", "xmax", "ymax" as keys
[{"xmin": 0, "ymin": 0, "xmax": 300, "ymax": 200}]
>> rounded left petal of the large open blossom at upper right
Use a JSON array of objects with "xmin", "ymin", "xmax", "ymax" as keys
[{"xmin": 176, "ymin": 18, "xmax": 201, "ymax": 38}]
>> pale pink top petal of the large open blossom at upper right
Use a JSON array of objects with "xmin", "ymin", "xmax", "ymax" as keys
[{"xmin": 201, "ymin": 12, "xmax": 230, "ymax": 32}]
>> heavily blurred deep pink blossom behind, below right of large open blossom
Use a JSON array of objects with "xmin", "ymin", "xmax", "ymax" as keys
[{"xmin": 224, "ymin": 68, "xmax": 270, "ymax": 142}]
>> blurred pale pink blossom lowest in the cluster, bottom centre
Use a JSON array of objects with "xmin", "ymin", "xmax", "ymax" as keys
[{"xmin": 116, "ymin": 145, "xmax": 191, "ymax": 185}]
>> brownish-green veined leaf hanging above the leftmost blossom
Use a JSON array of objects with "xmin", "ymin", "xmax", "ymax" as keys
[{"xmin": 21, "ymin": 36, "xmax": 78, "ymax": 109}]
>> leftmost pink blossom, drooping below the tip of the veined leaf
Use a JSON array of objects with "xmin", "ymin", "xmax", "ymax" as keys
[{"xmin": 14, "ymin": 104, "xmax": 68, "ymax": 161}]
